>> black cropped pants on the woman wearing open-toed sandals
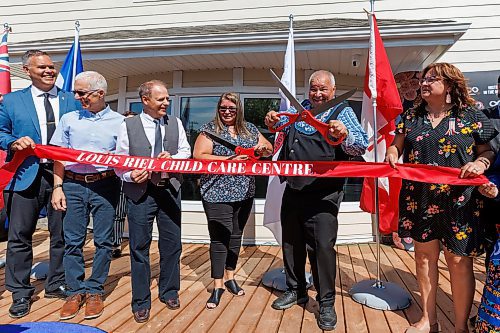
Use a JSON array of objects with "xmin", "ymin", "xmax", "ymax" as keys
[{"xmin": 203, "ymin": 198, "xmax": 253, "ymax": 279}]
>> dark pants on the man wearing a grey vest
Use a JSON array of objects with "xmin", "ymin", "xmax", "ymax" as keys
[{"xmin": 127, "ymin": 183, "xmax": 182, "ymax": 312}]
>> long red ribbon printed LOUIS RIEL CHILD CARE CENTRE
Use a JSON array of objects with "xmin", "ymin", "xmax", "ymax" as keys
[{"xmin": 0, "ymin": 145, "xmax": 488, "ymax": 190}]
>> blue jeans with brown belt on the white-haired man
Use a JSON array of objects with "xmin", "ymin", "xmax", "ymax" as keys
[{"xmin": 63, "ymin": 177, "xmax": 120, "ymax": 295}]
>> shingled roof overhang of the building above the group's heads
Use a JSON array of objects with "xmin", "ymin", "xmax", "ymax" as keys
[{"xmin": 9, "ymin": 19, "xmax": 470, "ymax": 79}]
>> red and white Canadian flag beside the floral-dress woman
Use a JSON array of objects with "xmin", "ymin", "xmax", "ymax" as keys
[{"xmin": 360, "ymin": 14, "xmax": 403, "ymax": 233}]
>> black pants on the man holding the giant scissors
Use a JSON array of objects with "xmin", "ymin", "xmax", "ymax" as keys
[{"xmin": 281, "ymin": 187, "xmax": 344, "ymax": 305}]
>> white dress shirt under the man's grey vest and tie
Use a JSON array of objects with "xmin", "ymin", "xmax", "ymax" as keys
[{"xmin": 115, "ymin": 112, "xmax": 191, "ymax": 183}]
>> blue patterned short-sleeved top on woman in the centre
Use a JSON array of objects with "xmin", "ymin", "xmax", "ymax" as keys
[{"xmin": 200, "ymin": 121, "xmax": 259, "ymax": 202}]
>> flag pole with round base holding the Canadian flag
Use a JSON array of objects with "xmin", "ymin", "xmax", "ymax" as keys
[{"xmin": 349, "ymin": 0, "xmax": 411, "ymax": 311}]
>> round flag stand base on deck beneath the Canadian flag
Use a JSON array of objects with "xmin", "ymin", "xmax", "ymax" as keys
[{"xmin": 349, "ymin": 280, "xmax": 411, "ymax": 311}]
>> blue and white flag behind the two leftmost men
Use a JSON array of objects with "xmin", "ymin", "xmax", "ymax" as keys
[{"xmin": 56, "ymin": 21, "xmax": 83, "ymax": 91}]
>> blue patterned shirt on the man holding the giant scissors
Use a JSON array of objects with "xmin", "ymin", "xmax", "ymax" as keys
[{"xmin": 275, "ymin": 99, "xmax": 368, "ymax": 156}]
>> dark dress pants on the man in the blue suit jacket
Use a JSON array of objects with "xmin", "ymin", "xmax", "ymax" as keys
[{"xmin": 4, "ymin": 165, "xmax": 64, "ymax": 300}]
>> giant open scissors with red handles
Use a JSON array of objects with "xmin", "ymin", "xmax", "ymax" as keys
[{"xmin": 269, "ymin": 69, "xmax": 357, "ymax": 146}]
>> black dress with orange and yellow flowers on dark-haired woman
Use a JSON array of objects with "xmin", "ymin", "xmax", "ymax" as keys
[{"xmin": 396, "ymin": 107, "xmax": 496, "ymax": 256}]
